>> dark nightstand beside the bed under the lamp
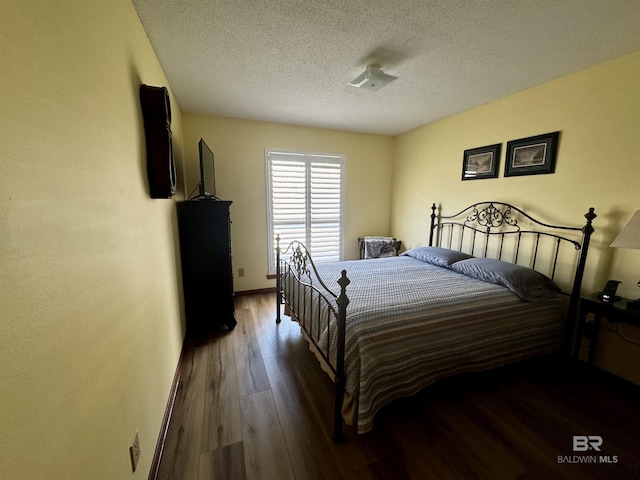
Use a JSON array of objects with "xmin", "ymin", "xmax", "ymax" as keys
[{"xmin": 573, "ymin": 293, "xmax": 640, "ymax": 364}]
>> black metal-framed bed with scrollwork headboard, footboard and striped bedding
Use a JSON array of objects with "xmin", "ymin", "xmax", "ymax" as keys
[{"xmin": 276, "ymin": 202, "xmax": 596, "ymax": 442}]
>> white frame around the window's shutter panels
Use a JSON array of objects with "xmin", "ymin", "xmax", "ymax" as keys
[{"xmin": 265, "ymin": 148, "xmax": 346, "ymax": 276}]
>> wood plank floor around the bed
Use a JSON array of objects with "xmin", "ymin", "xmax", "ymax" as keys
[{"xmin": 158, "ymin": 295, "xmax": 640, "ymax": 480}]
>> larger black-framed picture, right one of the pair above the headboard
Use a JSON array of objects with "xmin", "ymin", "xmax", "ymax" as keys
[{"xmin": 504, "ymin": 132, "xmax": 560, "ymax": 177}]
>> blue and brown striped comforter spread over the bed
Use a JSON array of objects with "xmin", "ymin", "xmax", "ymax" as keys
[{"xmin": 284, "ymin": 256, "xmax": 563, "ymax": 433}]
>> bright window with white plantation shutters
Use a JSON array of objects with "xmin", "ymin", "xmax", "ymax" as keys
[{"xmin": 267, "ymin": 150, "xmax": 344, "ymax": 274}]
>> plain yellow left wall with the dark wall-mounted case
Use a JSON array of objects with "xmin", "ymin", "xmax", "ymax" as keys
[{"xmin": 0, "ymin": 0, "xmax": 184, "ymax": 480}]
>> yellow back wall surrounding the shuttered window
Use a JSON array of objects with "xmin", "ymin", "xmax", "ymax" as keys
[{"xmin": 183, "ymin": 113, "xmax": 393, "ymax": 291}]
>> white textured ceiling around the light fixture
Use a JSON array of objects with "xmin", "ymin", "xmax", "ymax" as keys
[{"xmin": 133, "ymin": 0, "xmax": 640, "ymax": 135}]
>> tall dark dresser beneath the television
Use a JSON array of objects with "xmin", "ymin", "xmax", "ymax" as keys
[{"xmin": 178, "ymin": 199, "xmax": 236, "ymax": 334}]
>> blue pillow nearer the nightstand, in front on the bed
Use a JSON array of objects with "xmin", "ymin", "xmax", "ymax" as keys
[{"xmin": 451, "ymin": 258, "xmax": 560, "ymax": 301}]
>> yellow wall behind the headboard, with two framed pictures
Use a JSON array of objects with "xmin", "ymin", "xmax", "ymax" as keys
[{"xmin": 391, "ymin": 52, "xmax": 640, "ymax": 383}]
